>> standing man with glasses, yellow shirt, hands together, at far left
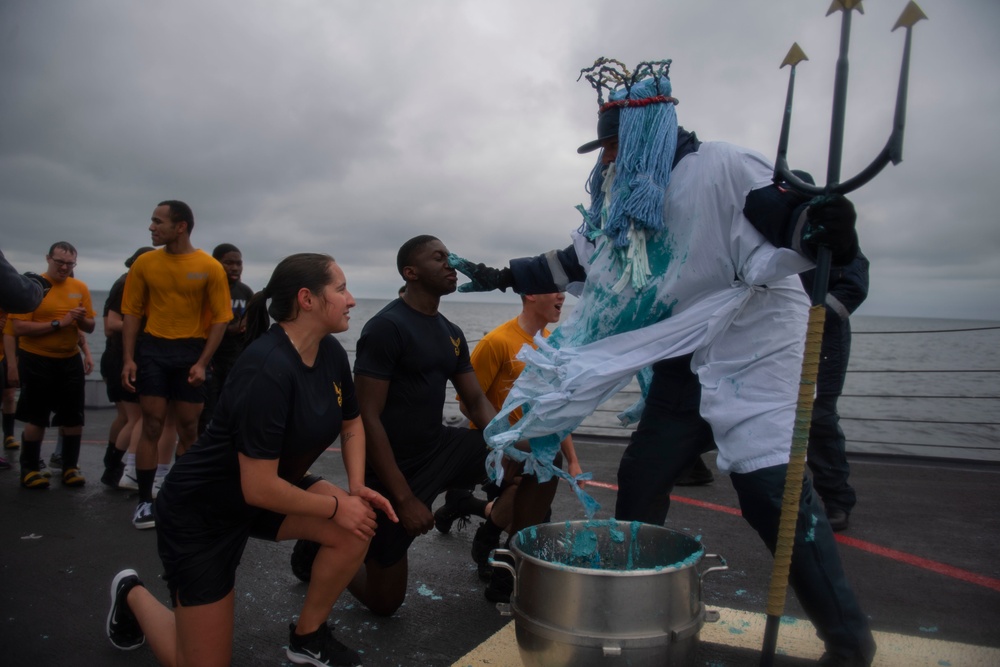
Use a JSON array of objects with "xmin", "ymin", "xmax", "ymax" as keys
[{"xmin": 9, "ymin": 241, "xmax": 94, "ymax": 489}]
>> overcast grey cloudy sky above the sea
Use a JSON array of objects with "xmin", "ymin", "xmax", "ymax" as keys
[{"xmin": 0, "ymin": 0, "xmax": 1000, "ymax": 320}]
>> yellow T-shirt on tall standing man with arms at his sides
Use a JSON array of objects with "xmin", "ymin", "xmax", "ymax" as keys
[{"xmin": 122, "ymin": 248, "xmax": 233, "ymax": 340}]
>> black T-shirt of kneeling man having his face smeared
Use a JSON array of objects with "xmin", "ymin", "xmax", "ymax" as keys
[{"xmin": 354, "ymin": 299, "xmax": 473, "ymax": 460}]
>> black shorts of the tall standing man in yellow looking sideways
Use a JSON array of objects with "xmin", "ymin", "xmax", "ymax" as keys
[{"xmin": 135, "ymin": 336, "xmax": 208, "ymax": 403}]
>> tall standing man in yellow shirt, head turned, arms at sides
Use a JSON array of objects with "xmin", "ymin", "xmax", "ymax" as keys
[{"xmin": 122, "ymin": 200, "xmax": 233, "ymax": 529}]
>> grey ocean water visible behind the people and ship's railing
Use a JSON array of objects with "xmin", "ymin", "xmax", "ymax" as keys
[{"xmin": 82, "ymin": 292, "xmax": 1000, "ymax": 462}]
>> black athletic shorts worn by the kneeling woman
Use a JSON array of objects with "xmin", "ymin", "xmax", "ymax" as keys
[{"xmin": 153, "ymin": 475, "xmax": 323, "ymax": 607}]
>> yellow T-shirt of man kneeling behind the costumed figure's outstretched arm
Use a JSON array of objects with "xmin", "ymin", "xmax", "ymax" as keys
[{"xmin": 470, "ymin": 317, "xmax": 549, "ymax": 428}]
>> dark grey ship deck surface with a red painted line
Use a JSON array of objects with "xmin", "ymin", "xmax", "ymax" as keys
[{"xmin": 0, "ymin": 410, "xmax": 1000, "ymax": 667}]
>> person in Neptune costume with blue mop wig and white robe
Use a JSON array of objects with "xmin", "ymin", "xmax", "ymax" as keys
[{"xmin": 451, "ymin": 58, "xmax": 875, "ymax": 665}]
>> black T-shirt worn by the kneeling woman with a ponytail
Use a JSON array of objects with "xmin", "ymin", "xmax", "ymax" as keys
[{"xmin": 157, "ymin": 324, "xmax": 360, "ymax": 519}]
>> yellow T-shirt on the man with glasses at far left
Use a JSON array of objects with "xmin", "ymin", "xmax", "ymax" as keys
[{"xmin": 8, "ymin": 274, "xmax": 94, "ymax": 359}]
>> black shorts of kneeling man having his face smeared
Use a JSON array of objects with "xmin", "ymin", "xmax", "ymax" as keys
[{"xmin": 365, "ymin": 426, "xmax": 489, "ymax": 567}]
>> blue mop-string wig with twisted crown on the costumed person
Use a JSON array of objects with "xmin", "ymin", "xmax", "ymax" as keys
[{"xmin": 581, "ymin": 58, "xmax": 677, "ymax": 251}]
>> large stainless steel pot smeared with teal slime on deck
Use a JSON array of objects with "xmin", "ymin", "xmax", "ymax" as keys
[{"xmin": 491, "ymin": 519, "xmax": 728, "ymax": 667}]
